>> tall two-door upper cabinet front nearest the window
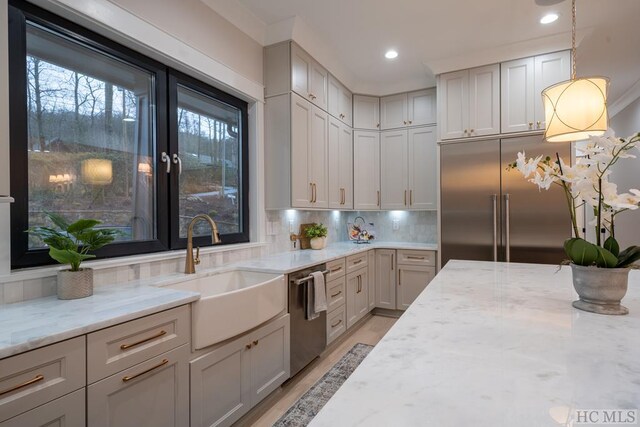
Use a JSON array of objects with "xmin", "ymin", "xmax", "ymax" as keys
[{"xmin": 292, "ymin": 94, "xmax": 329, "ymax": 208}]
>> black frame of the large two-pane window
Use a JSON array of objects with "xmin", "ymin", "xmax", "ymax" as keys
[{"xmin": 8, "ymin": 0, "xmax": 250, "ymax": 269}]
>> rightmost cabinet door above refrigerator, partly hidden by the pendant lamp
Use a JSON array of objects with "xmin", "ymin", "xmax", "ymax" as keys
[{"xmin": 534, "ymin": 50, "xmax": 571, "ymax": 129}]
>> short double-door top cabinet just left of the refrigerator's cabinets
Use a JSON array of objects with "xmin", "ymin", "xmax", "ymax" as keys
[{"xmin": 380, "ymin": 89, "xmax": 436, "ymax": 130}]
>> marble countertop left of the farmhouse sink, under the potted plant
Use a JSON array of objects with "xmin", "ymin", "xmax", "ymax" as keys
[{"xmin": 0, "ymin": 283, "xmax": 200, "ymax": 359}]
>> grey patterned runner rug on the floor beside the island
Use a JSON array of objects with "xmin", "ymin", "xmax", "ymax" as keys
[{"xmin": 274, "ymin": 343, "xmax": 373, "ymax": 427}]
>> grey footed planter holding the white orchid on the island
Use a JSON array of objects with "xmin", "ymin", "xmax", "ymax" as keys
[{"xmin": 571, "ymin": 264, "xmax": 630, "ymax": 315}]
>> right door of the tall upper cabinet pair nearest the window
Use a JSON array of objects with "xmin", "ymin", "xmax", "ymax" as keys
[{"xmin": 312, "ymin": 106, "xmax": 329, "ymax": 208}]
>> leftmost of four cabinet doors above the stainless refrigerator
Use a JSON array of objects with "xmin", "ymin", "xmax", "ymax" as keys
[{"xmin": 438, "ymin": 70, "xmax": 469, "ymax": 139}]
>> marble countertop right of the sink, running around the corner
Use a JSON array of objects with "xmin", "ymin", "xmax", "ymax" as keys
[{"xmin": 234, "ymin": 242, "xmax": 438, "ymax": 274}]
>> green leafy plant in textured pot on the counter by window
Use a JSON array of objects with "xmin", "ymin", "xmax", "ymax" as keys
[{"xmin": 27, "ymin": 212, "xmax": 121, "ymax": 299}]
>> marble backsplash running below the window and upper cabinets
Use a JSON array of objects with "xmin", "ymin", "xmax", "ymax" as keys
[{"xmin": 0, "ymin": 210, "xmax": 437, "ymax": 304}]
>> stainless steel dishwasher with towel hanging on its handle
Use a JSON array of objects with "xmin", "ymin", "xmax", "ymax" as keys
[{"xmin": 289, "ymin": 264, "xmax": 327, "ymax": 377}]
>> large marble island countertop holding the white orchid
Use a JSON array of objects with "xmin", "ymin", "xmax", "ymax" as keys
[{"xmin": 311, "ymin": 261, "xmax": 640, "ymax": 427}]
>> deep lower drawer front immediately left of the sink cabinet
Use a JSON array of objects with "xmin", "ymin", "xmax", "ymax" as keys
[{"xmin": 87, "ymin": 344, "xmax": 190, "ymax": 427}]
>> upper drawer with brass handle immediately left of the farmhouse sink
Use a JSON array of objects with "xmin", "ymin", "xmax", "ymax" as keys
[{"xmin": 87, "ymin": 305, "xmax": 191, "ymax": 384}]
